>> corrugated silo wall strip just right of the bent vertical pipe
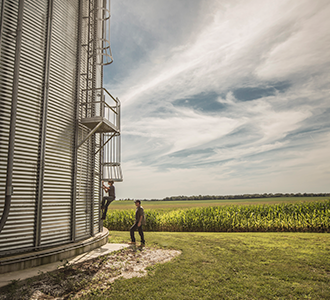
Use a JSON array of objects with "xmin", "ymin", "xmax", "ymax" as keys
[{"xmin": 1, "ymin": 0, "xmax": 47, "ymax": 251}]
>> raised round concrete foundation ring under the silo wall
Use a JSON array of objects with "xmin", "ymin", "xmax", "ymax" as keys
[{"xmin": 0, "ymin": 227, "xmax": 109, "ymax": 274}]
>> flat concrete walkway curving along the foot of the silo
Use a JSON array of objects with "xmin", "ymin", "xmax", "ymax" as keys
[{"xmin": 0, "ymin": 243, "xmax": 129, "ymax": 287}]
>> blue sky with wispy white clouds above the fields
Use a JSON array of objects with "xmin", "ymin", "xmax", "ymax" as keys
[{"xmin": 104, "ymin": 0, "xmax": 330, "ymax": 199}]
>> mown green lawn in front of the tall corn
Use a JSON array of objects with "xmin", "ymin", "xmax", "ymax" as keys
[{"xmin": 87, "ymin": 231, "xmax": 330, "ymax": 300}]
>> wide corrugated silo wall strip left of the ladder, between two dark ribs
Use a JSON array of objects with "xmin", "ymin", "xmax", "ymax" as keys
[{"xmin": 41, "ymin": 0, "xmax": 78, "ymax": 245}]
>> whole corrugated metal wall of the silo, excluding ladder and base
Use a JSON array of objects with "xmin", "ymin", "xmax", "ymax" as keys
[{"xmin": 0, "ymin": 0, "xmax": 99, "ymax": 255}]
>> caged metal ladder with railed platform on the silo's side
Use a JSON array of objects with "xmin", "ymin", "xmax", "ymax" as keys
[{"xmin": 77, "ymin": 0, "xmax": 123, "ymax": 181}]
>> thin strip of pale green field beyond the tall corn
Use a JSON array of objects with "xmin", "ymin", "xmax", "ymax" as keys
[{"xmin": 109, "ymin": 197, "xmax": 329, "ymax": 210}]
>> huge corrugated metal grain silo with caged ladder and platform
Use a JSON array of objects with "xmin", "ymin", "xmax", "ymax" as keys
[{"xmin": 0, "ymin": 0, "xmax": 122, "ymax": 273}]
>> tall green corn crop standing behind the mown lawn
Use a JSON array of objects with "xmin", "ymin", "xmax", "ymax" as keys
[{"xmin": 104, "ymin": 200, "xmax": 330, "ymax": 232}]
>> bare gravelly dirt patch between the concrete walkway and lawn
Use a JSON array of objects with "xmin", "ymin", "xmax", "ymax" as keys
[{"xmin": 0, "ymin": 248, "xmax": 181, "ymax": 300}]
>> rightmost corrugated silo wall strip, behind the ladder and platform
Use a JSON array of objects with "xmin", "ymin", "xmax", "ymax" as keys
[{"xmin": 76, "ymin": 0, "xmax": 102, "ymax": 238}]
